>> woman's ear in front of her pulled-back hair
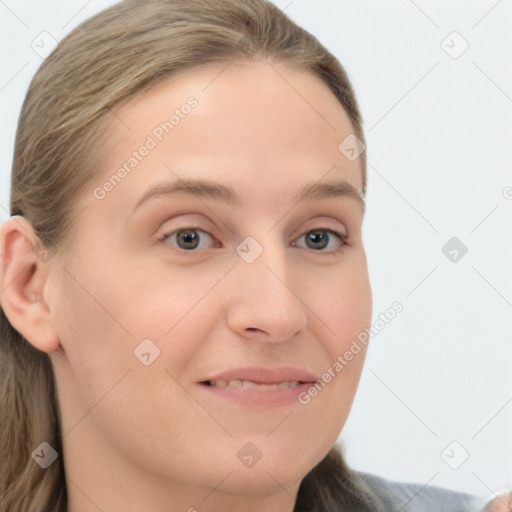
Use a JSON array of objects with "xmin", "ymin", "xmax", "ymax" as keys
[{"xmin": 0, "ymin": 215, "xmax": 59, "ymax": 352}]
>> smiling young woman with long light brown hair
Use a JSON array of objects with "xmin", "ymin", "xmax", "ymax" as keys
[{"xmin": 0, "ymin": 0, "xmax": 500, "ymax": 512}]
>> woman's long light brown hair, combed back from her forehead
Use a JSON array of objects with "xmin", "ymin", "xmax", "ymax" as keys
[{"xmin": 0, "ymin": 0, "xmax": 378, "ymax": 512}]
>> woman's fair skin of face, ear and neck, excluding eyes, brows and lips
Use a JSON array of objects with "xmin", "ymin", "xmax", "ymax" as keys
[{"xmin": 1, "ymin": 62, "xmax": 372, "ymax": 512}]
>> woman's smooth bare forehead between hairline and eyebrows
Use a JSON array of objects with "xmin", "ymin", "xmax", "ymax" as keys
[{"xmin": 86, "ymin": 62, "xmax": 362, "ymax": 215}]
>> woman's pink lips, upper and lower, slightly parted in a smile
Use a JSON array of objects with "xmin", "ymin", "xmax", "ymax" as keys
[{"xmin": 198, "ymin": 366, "xmax": 318, "ymax": 408}]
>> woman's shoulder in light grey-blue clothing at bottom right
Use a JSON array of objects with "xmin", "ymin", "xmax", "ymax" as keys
[{"xmin": 354, "ymin": 471, "xmax": 485, "ymax": 512}]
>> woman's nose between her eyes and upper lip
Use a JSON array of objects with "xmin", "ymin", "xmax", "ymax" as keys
[{"xmin": 226, "ymin": 237, "xmax": 308, "ymax": 342}]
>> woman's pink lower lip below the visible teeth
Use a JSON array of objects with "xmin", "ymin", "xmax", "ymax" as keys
[{"xmin": 199, "ymin": 382, "xmax": 314, "ymax": 407}]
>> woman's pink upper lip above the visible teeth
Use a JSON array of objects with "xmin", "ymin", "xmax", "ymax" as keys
[{"xmin": 201, "ymin": 366, "xmax": 318, "ymax": 384}]
